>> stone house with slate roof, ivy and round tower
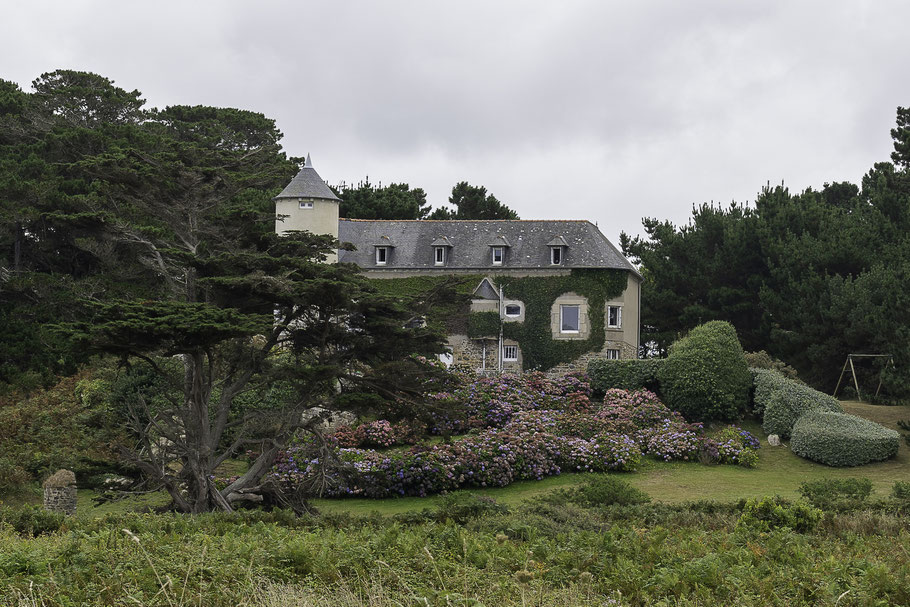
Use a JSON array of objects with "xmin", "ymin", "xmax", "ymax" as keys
[{"xmin": 274, "ymin": 156, "xmax": 642, "ymax": 372}]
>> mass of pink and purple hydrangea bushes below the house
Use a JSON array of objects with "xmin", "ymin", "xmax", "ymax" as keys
[{"xmin": 275, "ymin": 374, "xmax": 759, "ymax": 497}]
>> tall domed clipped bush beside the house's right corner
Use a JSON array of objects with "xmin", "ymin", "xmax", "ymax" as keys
[{"xmin": 657, "ymin": 321, "xmax": 752, "ymax": 421}]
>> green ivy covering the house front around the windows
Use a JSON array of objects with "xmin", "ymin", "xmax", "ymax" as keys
[{"xmin": 373, "ymin": 269, "xmax": 628, "ymax": 370}]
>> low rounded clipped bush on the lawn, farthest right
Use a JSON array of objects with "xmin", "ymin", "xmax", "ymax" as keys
[{"xmin": 790, "ymin": 411, "xmax": 900, "ymax": 466}]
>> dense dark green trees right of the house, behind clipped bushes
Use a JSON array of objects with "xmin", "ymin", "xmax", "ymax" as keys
[{"xmin": 621, "ymin": 108, "xmax": 910, "ymax": 394}]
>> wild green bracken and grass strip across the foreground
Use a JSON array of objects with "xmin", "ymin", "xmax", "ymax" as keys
[{"xmin": 0, "ymin": 489, "xmax": 910, "ymax": 607}]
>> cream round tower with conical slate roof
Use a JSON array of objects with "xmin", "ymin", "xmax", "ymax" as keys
[{"xmin": 273, "ymin": 154, "xmax": 341, "ymax": 263}]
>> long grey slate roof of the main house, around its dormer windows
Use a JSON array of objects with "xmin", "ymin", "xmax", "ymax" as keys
[{"xmin": 338, "ymin": 219, "xmax": 638, "ymax": 274}]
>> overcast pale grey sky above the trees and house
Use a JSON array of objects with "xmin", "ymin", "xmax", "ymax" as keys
[{"xmin": 0, "ymin": 0, "xmax": 910, "ymax": 242}]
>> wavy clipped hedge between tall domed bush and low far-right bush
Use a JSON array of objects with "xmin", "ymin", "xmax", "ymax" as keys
[{"xmin": 752, "ymin": 369, "xmax": 843, "ymax": 438}]
